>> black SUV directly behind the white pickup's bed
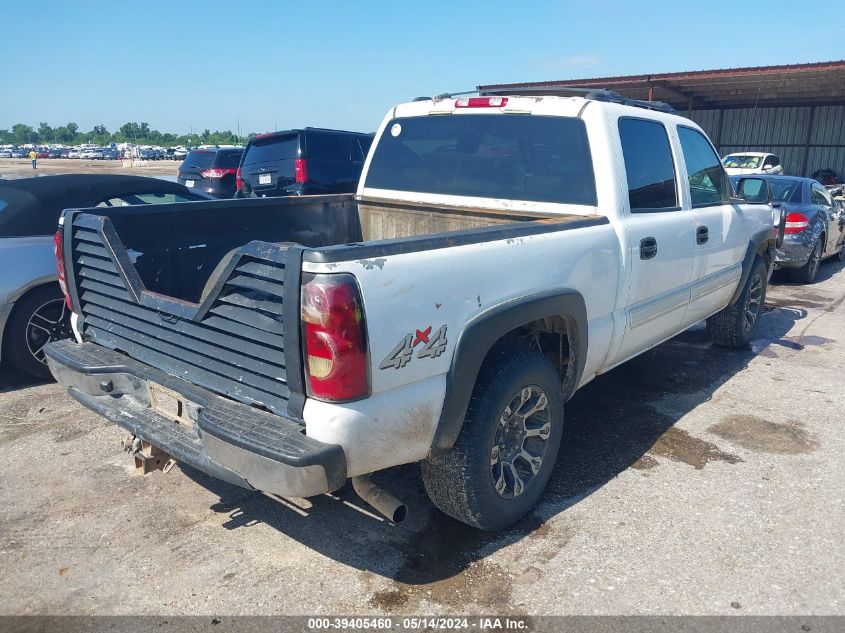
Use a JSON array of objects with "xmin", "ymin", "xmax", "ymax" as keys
[{"xmin": 236, "ymin": 127, "xmax": 373, "ymax": 198}]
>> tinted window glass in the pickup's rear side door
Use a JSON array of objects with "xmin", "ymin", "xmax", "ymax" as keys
[{"xmin": 619, "ymin": 118, "xmax": 678, "ymax": 213}]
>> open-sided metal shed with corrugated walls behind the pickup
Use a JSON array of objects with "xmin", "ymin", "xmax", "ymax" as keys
[{"xmin": 478, "ymin": 60, "xmax": 845, "ymax": 182}]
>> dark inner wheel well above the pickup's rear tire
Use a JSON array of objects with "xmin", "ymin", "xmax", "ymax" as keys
[{"xmin": 484, "ymin": 315, "xmax": 578, "ymax": 398}]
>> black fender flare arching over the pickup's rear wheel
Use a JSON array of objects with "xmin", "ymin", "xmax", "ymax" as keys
[{"xmin": 431, "ymin": 289, "xmax": 587, "ymax": 453}]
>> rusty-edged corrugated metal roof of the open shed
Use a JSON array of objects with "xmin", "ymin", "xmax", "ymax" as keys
[{"xmin": 478, "ymin": 60, "xmax": 845, "ymax": 110}]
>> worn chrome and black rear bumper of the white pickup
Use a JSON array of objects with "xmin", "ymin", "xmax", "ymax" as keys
[{"xmin": 45, "ymin": 341, "xmax": 346, "ymax": 497}]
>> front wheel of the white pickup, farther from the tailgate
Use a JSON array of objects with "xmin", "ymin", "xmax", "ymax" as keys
[{"xmin": 707, "ymin": 257, "xmax": 768, "ymax": 347}]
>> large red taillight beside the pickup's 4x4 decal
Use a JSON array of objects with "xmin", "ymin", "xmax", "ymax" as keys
[{"xmin": 301, "ymin": 274, "xmax": 369, "ymax": 402}]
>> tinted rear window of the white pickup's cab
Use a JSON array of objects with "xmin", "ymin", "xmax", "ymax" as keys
[{"xmin": 366, "ymin": 114, "xmax": 596, "ymax": 205}]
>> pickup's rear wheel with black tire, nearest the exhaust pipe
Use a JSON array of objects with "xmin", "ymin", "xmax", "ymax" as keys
[{"xmin": 422, "ymin": 347, "xmax": 563, "ymax": 531}]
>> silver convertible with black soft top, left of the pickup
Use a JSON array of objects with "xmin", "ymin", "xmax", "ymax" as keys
[{"xmin": 0, "ymin": 174, "xmax": 210, "ymax": 377}]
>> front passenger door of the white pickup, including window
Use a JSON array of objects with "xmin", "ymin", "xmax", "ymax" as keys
[{"xmin": 677, "ymin": 125, "xmax": 749, "ymax": 324}]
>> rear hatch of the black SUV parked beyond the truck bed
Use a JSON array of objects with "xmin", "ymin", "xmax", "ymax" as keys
[{"xmin": 241, "ymin": 132, "xmax": 301, "ymax": 196}]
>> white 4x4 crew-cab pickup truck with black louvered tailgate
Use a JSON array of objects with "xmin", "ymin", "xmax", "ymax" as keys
[{"xmin": 46, "ymin": 92, "xmax": 777, "ymax": 530}]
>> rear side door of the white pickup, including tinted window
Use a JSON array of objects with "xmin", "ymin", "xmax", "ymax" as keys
[{"xmin": 616, "ymin": 117, "xmax": 694, "ymax": 362}]
